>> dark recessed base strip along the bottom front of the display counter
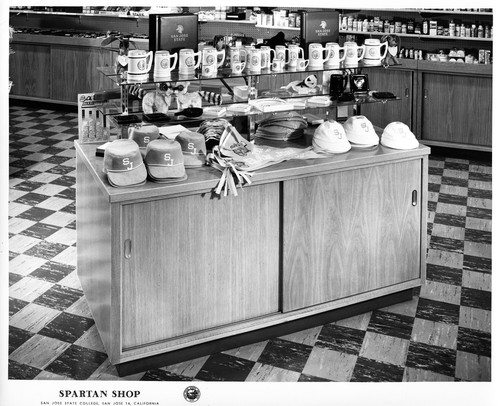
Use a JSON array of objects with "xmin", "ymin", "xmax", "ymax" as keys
[{"xmin": 115, "ymin": 288, "xmax": 414, "ymax": 377}]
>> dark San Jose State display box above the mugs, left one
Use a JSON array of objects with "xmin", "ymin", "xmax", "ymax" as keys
[{"xmin": 149, "ymin": 13, "xmax": 198, "ymax": 53}]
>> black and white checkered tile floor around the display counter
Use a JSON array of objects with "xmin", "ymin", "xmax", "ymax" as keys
[{"xmin": 9, "ymin": 106, "xmax": 492, "ymax": 382}]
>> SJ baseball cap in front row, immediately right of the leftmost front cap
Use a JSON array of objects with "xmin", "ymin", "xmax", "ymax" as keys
[{"xmin": 144, "ymin": 138, "xmax": 187, "ymax": 183}]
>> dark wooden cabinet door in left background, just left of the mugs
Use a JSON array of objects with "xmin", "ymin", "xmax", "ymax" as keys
[{"xmin": 51, "ymin": 45, "xmax": 112, "ymax": 102}]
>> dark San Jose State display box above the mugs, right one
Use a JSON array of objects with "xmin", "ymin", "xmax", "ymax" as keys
[{"xmin": 300, "ymin": 11, "xmax": 339, "ymax": 59}]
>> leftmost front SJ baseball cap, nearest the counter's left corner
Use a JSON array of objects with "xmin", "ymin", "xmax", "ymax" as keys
[{"xmin": 103, "ymin": 139, "xmax": 147, "ymax": 187}]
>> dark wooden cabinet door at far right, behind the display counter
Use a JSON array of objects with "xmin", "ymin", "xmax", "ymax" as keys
[{"xmin": 421, "ymin": 73, "xmax": 493, "ymax": 147}]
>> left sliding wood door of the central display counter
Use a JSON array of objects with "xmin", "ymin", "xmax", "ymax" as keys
[{"xmin": 122, "ymin": 183, "xmax": 279, "ymax": 350}]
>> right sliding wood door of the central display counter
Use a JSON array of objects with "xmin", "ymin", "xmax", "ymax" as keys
[{"xmin": 283, "ymin": 160, "xmax": 421, "ymax": 311}]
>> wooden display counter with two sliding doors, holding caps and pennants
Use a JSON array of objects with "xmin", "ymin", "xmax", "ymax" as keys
[{"xmin": 75, "ymin": 142, "xmax": 430, "ymax": 374}]
